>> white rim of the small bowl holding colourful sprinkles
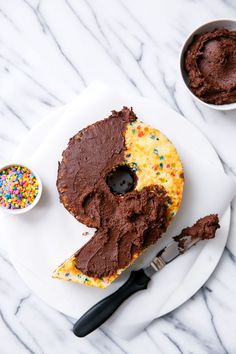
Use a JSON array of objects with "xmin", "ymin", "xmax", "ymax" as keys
[{"xmin": 0, "ymin": 162, "xmax": 43, "ymax": 215}]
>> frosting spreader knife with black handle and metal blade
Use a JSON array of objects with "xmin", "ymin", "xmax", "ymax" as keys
[{"xmin": 73, "ymin": 232, "xmax": 200, "ymax": 337}]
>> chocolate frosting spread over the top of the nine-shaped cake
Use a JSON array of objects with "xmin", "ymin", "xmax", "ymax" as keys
[{"xmin": 57, "ymin": 107, "xmax": 168, "ymax": 278}]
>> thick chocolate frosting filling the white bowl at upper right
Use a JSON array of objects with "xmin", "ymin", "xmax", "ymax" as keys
[{"xmin": 185, "ymin": 29, "xmax": 236, "ymax": 104}]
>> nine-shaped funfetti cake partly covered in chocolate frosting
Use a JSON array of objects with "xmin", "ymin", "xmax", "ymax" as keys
[{"xmin": 54, "ymin": 107, "xmax": 184, "ymax": 287}]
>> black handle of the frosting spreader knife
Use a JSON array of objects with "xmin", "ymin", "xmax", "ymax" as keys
[{"xmin": 73, "ymin": 269, "xmax": 150, "ymax": 337}]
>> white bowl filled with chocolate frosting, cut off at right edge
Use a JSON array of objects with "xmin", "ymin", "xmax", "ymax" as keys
[{"xmin": 180, "ymin": 19, "xmax": 236, "ymax": 110}]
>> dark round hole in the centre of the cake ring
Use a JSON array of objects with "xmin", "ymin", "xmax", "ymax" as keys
[{"xmin": 106, "ymin": 165, "xmax": 135, "ymax": 195}]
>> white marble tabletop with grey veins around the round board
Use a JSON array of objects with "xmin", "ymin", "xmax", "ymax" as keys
[{"xmin": 0, "ymin": 0, "xmax": 236, "ymax": 354}]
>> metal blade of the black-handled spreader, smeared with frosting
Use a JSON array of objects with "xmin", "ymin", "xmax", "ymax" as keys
[{"xmin": 144, "ymin": 236, "xmax": 201, "ymax": 277}]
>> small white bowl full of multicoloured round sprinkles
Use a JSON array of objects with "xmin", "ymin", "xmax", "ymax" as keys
[{"xmin": 0, "ymin": 163, "xmax": 42, "ymax": 214}]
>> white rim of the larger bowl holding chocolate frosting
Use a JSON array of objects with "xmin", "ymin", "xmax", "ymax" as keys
[{"xmin": 179, "ymin": 18, "xmax": 236, "ymax": 111}]
